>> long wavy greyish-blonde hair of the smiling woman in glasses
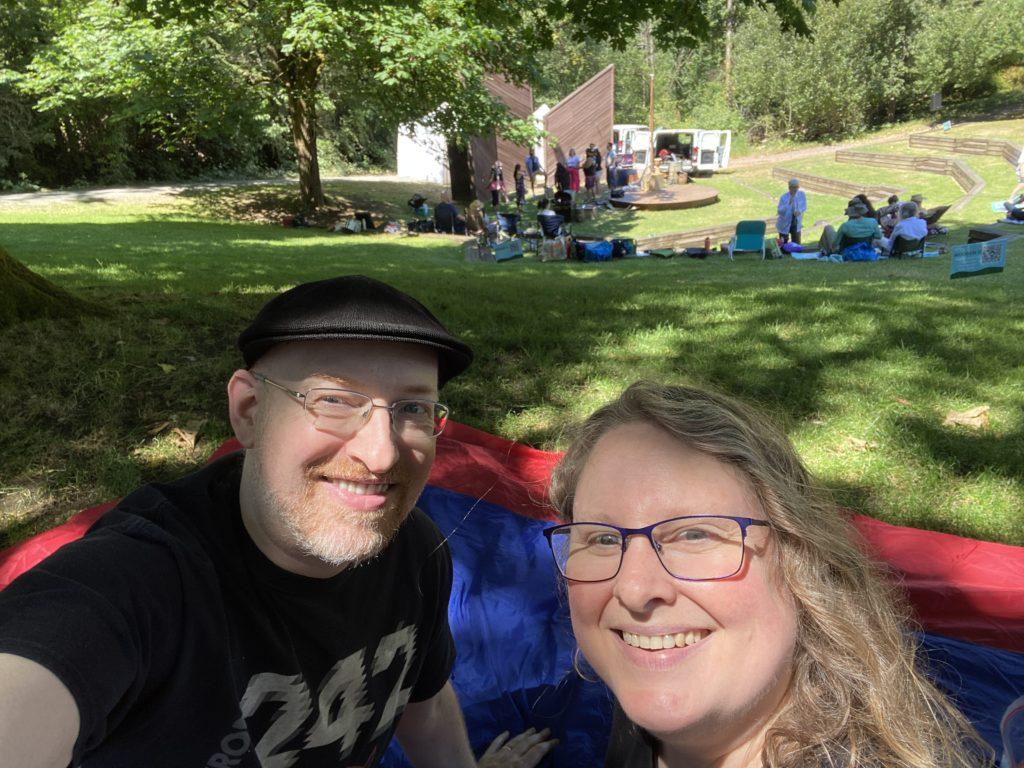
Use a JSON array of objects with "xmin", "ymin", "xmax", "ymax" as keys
[{"xmin": 550, "ymin": 382, "xmax": 992, "ymax": 768}]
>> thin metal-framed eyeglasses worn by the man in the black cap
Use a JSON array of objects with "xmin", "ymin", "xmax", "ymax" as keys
[{"xmin": 253, "ymin": 373, "xmax": 449, "ymax": 441}]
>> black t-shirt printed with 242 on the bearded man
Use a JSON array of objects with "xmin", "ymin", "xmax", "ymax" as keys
[{"xmin": 0, "ymin": 454, "xmax": 455, "ymax": 768}]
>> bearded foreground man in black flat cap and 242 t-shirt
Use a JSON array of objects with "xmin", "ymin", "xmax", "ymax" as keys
[{"xmin": 0, "ymin": 276, "xmax": 552, "ymax": 768}]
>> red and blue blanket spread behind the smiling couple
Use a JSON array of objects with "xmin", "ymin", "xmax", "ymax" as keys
[{"xmin": 0, "ymin": 422, "xmax": 1024, "ymax": 768}]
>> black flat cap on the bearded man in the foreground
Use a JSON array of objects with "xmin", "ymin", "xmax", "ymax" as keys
[{"xmin": 239, "ymin": 274, "xmax": 473, "ymax": 386}]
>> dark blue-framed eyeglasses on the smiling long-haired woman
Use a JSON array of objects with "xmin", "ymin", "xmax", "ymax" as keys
[{"xmin": 544, "ymin": 515, "xmax": 768, "ymax": 582}]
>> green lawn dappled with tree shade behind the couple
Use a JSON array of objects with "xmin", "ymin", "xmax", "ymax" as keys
[{"xmin": 0, "ymin": 123, "xmax": 1024, "ymax": 544}]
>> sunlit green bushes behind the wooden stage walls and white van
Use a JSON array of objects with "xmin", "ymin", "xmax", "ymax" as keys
[{"xmin": 536, "ymin": 0, "xmax": 1024, "ymax": 139}]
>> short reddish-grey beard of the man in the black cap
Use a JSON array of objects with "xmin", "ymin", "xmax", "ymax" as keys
[{"xmin": 247, "ymin": 451, "xmax": 413, "ymax": 567}]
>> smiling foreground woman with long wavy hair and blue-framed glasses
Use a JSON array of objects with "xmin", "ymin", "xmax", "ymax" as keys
[{"xmin": 546, "ymin": 382, "xmax": 992, "ymax": 768}]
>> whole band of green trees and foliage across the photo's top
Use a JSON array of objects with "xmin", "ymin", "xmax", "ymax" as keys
[{"xmin": 0, "ymin": 0, "xmax": 1024, "ymax": 196}]
